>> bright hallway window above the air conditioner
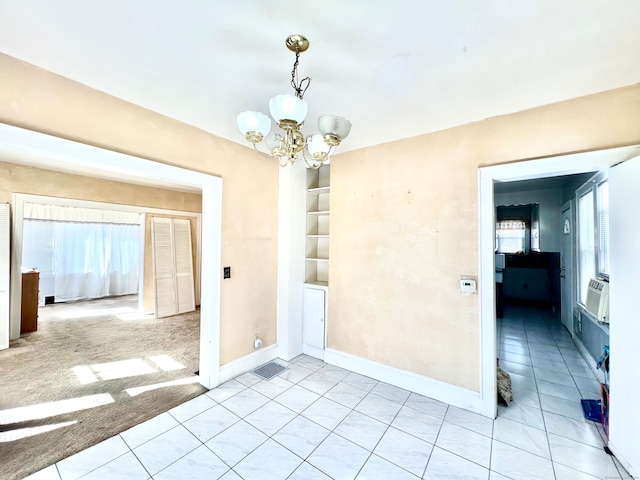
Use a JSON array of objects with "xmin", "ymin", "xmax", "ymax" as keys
[{"xmin": 576, "ymin": 173, "xmax": 609, "ymax": 304}]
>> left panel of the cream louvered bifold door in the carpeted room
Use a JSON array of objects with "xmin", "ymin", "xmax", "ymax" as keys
[{"xmin": 151, "ymin": 217, "xmax": 178, "ymax": 318}]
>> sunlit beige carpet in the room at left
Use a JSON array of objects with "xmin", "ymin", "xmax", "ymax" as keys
[{"xmin": 0, "ymin": 296, "xmax": 206, "ymax": 479}]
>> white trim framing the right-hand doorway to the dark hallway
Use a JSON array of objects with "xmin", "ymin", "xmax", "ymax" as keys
[{"xmin": 478, "ymin": 145, "xmax": 640, "ymax": 418}]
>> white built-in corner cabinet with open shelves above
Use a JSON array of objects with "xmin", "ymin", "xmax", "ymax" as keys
[{"xmin": 302, "ymin": 165, "xmax": 331, "ymax": 358}]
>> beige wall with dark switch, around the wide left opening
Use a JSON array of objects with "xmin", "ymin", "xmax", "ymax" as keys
[{"xmin": 0, "ymin": 55, "xmax": 278, "ymax": 364}]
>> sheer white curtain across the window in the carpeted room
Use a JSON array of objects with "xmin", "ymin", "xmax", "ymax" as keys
[{"xmin": 23, "ymin": 204, "xmax": 142, "ymax": 301}]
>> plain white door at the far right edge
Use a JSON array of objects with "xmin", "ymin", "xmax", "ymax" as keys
[{"xmin": 609, "ymin": 157, "xmax": 640, "ymax": 478}]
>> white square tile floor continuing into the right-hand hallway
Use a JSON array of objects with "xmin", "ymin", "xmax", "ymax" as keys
[{"xmin": 23, "ymin": 306, "xmax": 631, "ymax": 480}]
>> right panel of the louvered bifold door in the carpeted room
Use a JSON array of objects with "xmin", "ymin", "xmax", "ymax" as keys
[{"xmin": 173, "ymin": 218, "xmax": 196, "ymax": 313}]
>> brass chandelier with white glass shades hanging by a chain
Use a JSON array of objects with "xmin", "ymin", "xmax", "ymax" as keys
[{"xmin": 238, "ymin": 35, "xmax": 351, "ymax": 168}]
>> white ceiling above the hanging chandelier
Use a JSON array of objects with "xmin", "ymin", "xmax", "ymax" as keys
[{"xmin": 0, "ymin": 0, "xmax": 640, "ymax": 151}]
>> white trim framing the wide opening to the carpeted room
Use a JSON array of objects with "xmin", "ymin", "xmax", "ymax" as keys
[{"xmin": 0, "ymin": 124, "xmax": 222, "ymax": 388}]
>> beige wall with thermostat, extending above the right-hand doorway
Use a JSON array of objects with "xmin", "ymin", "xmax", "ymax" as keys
[{"xmin": 328, "ymin": 84, "xmax": 640, "ymax": 391}]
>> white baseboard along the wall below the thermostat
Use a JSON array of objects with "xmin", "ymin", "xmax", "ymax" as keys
[{"xmin": 324, "ymin": 348, "xmax": 493, "ymax": 418}]
